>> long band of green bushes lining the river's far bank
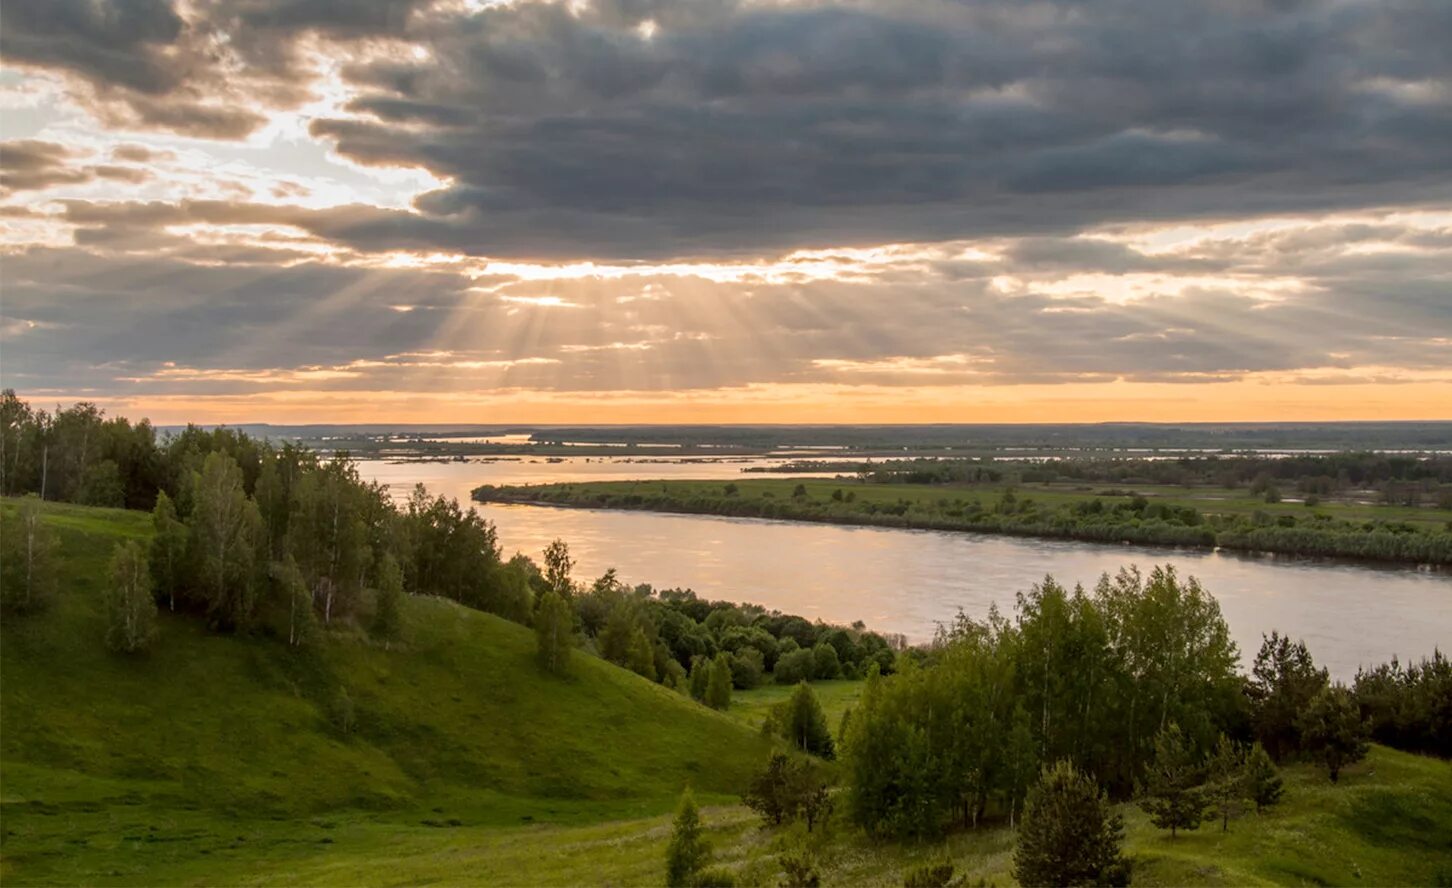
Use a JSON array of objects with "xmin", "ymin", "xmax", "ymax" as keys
[{"xmin": 473, "ymin": 483, "xmax": 1452, "ymax": 564}]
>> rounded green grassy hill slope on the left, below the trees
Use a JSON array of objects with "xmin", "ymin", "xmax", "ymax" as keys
[{"xmin": 0, "ymin": 501, "xmax": 767, "ymax": 881}]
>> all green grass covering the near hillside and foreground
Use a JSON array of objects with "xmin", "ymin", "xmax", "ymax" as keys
[{"xmin": 0, "ymin": 502, "xmax": 1452, "ymax": 885}]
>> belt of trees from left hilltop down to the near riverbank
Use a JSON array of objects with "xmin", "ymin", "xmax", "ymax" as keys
[{"xmin": 0, "ymin": 390, "xmax": 903, "ymax": 691}]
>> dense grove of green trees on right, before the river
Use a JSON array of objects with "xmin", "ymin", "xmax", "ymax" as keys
[{"xmin": 842, "ymin": 567, "xmax": 1452, "ymax": 837}]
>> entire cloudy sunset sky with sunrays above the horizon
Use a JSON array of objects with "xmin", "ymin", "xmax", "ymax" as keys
[{"xmin": 0, "ymin": 0, "xmax": 1452, "ymax": 424}]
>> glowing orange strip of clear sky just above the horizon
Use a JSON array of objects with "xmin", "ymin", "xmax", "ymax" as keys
[{"xmin": 68, "ymin": 382, "xmax": 1452, "ymax": 425}]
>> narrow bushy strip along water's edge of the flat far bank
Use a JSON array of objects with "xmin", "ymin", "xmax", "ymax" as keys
[{"xmin": 473, "ymin": 479, "xmax": 1452, "ymax": 564}]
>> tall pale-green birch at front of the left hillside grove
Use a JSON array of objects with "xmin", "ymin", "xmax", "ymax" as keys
[{"xmin": 187, "ymin": 451, "xmax": 261, "ymax": 628}]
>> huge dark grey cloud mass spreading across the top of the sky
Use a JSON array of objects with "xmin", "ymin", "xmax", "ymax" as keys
[{"xmin": 3, "ymin": 0, "xmax": 1452, "ymax": 258}]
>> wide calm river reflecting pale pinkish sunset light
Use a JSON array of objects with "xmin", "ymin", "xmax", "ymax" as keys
[{"xmin": 359, "ymin": 457, "xmax": 1452, "ymax": 679}]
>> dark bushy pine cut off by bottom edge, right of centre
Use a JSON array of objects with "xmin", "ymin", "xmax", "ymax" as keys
[{"xmin": 1013, "ymin": 762, "xmax": 1130, "ymax": 887}]
